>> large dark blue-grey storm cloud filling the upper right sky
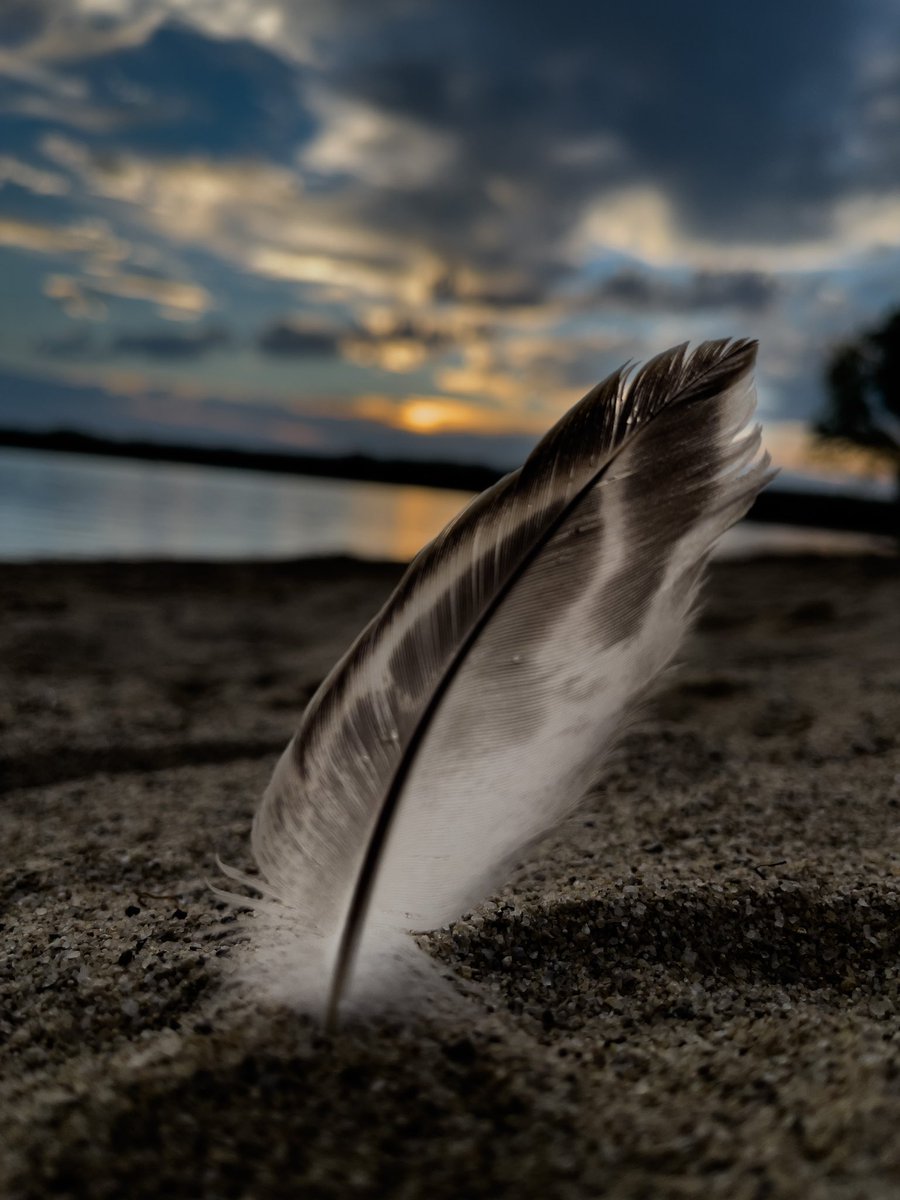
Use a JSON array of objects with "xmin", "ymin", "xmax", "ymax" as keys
[{"xmin": 321, "ymin": 0, "xmax": 900, "ymax": 255}]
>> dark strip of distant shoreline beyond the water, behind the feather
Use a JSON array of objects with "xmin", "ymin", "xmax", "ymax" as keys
[{"xmin": 0, "ymin": 430, "xmax": 900, "ymax": 536}]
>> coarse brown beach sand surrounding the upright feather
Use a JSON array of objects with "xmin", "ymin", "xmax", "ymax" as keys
[{"xmin": 0, "ymin": 559, "xmax": 900, "ymax": 1200}]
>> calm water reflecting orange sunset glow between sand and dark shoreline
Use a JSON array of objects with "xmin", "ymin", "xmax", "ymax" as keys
[{"xmin": 0, "ymin": 450, "xmax": 876, "ymax": 562}]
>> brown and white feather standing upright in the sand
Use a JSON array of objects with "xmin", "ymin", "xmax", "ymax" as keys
[{"xmin": 229, "ymin": 341, "xmax": 769, "ymax": 1024}]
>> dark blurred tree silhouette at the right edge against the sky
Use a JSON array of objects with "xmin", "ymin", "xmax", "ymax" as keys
[{"xmin": 815, "ymin": 308, "xmax": 900, "ymax": 503}]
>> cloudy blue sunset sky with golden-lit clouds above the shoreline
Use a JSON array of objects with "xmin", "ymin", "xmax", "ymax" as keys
[{"xmin": 0, "ymin": 0, "xmax": 900, "ymax": 477}]
